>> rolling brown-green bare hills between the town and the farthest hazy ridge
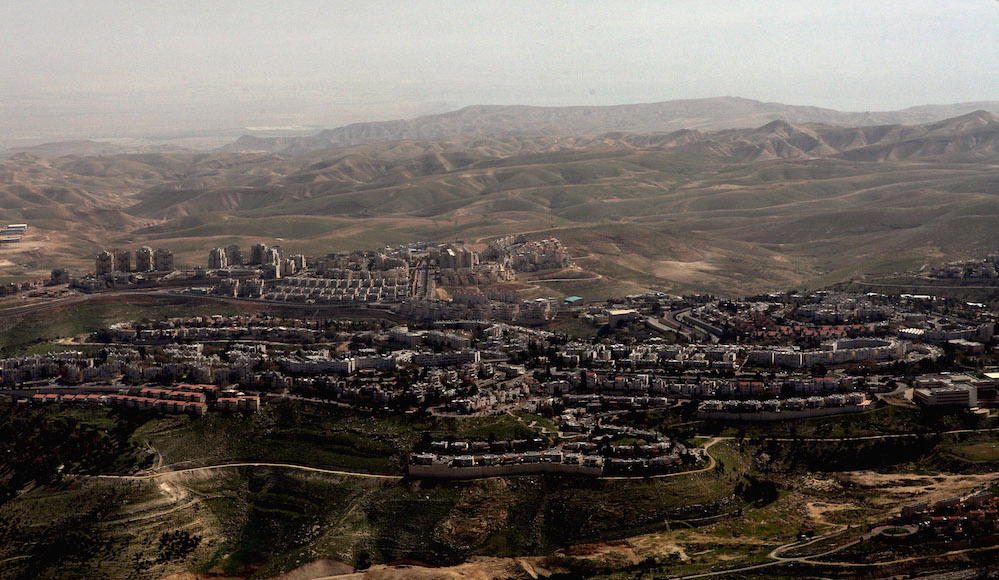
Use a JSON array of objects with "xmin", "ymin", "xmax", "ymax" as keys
[{"xmin": 0, "ymin": 111, "xmax": 999, "ymax": 295}]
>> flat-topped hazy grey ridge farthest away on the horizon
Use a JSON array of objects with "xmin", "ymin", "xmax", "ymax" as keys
[{"xmin": 221, "ymin": 97, "xmax": 999, "ymax": 155}]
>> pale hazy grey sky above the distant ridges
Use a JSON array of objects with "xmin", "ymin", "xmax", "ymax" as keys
[{"xmin": 0, "ymin": 0, "xmax": 999, "ymax": 142}]
